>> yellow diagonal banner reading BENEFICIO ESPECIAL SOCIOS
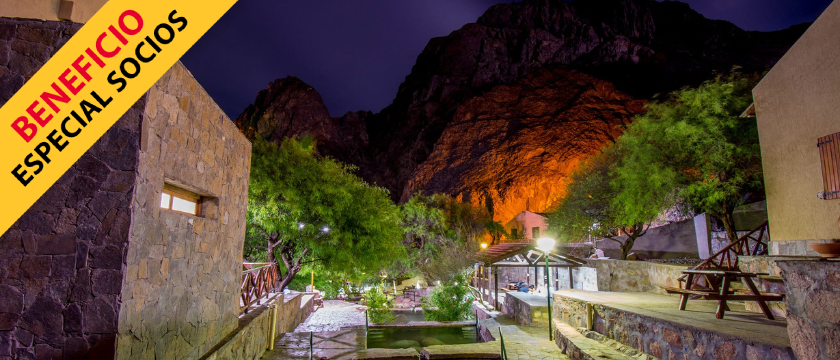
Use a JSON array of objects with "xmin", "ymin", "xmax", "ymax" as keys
[{"xmin": 0, "ymin": 0, "xmax": 236, "ymax": 233}]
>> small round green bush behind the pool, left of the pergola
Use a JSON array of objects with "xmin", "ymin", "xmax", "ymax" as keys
[{"xmin": 421, "ymin": 275, "xmax": 472, "ymax": 321}]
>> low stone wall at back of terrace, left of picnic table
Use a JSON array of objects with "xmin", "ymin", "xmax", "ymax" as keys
[{"xmin": 588, "ymin": 260, "xmax": 689, "ymax": 294}]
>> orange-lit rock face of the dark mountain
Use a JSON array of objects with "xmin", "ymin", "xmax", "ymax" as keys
[{"xmin": 402, "ymin": 67, "xmax": 643, "ymax": 222}]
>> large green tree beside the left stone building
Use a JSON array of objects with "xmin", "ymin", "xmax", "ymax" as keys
[{"xmin": 246, "ymin": 139, "xmax": 404, "ymax": 289}]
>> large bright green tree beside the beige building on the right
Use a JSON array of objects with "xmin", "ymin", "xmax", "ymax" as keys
[{"xmin": 614, "ymin": 75, "xmax": 764, "ymax": 242}]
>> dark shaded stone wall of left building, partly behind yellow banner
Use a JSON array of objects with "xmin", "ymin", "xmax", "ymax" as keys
[{"xmin": 0, "ymin": 18, "xmax": 141, "ymax": 359}]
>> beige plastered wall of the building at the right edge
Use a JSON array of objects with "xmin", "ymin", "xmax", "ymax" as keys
[{"xmin": 753, "ymin": 1, "xmax": 840, "ymax": 255}]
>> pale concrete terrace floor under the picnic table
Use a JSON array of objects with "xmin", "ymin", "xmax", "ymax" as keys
[{"xmin": 555, "ymin": 289, "xmax": 790, "ymax": 347}]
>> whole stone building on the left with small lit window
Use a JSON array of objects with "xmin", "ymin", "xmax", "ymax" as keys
[{"xmin": 0, "ymin": 18, "xmax": 251, "ymax": 359}]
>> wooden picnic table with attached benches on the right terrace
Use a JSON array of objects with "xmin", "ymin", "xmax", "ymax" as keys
[{"xmin": 662, "ymin": 270, "xmax": 785, "ymax": 320}]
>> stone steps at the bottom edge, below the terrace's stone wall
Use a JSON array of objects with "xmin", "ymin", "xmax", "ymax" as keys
[{"xmin": 554, "ymin": 321, "xmax": 656, "ymax": 360}]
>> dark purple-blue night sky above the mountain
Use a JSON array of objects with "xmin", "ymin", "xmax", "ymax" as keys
[{"xmin": 182, "ymin": 0, "xmax": 831, "ymax": 118}]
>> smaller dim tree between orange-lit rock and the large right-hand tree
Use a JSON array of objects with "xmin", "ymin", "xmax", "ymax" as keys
[{"xmin": 548, "ymin": 146, "xmax": 659, "ymax": 260}]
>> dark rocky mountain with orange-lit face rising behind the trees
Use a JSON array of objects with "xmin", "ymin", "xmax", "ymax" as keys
[{"xmin": 236, "ymin": 0, "xmax": 805, "ymax": 221}]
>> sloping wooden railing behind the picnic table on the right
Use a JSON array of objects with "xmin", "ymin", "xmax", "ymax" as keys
[{"xmin": 678, "ymin": 221, "xmax": 769, "ymax": 290}]
